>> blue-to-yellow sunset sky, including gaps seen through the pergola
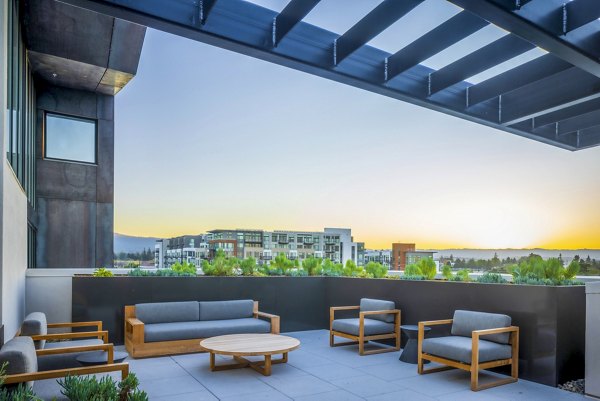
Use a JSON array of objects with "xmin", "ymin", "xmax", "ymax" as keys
[{"xmin": 115, "ymin": 0, "xmax": 600, "ymax": 248}]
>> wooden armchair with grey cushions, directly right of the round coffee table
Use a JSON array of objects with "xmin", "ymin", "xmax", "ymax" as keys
[{"xmin": 329, "ymin": 298, "xmax": 400, "ymax": 355}]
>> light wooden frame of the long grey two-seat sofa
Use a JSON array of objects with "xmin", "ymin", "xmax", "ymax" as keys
[{"xmin": 125, "ymin": 301, "xmax": 280, "ymax": 358}]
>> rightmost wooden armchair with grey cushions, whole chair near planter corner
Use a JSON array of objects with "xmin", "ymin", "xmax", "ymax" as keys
[{"xmin": 417, "ymin": 311, "xmax": 519, "ymax": 391}]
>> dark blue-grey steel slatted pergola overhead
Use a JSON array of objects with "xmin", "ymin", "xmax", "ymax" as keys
[{"xmin": 61, "ymin": 0, "xmax": 600, "ymax": 150}]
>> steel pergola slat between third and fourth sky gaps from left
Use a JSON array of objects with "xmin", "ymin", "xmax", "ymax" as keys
[{"xmin": 385, "ymin": 11, "xmax": 488, "ymax": 80}]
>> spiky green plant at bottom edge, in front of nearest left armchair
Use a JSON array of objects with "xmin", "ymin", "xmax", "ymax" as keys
[{"xmin": 58, "ymin": 373, "xmax": 148, "ymax": 401}]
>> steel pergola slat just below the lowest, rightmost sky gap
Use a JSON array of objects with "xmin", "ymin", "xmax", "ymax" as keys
[{"xmin": 467, "ymin": 54, "xmax": 573, "ymax": 107}]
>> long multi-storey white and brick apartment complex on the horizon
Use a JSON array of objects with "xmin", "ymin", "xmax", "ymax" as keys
[{"xmin": 155, "ymin": 228, "xmax": 365, "ymax": 268}]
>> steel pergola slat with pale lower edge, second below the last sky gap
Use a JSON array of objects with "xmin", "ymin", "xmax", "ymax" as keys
[{"xmin": 500, "ymin": 67, "xmax": 600, "ymax": 126}]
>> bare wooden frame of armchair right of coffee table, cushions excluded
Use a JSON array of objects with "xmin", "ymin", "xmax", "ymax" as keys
[{"xmin": 329, "ymin": 305, "xmax": 400, "ymax": 356}]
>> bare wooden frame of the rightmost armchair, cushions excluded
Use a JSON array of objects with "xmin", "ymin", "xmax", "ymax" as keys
[{"xmin": 417, "ymin": 319, "xmax": 519, "ymax": 391}]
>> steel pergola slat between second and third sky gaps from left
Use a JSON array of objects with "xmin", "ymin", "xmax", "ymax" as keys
[{"xmin": 333, "ymin": 0, "xmax": 424, "ymax": 65}]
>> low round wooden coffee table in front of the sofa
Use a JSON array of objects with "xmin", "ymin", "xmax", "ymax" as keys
[{"xmin": 200, "ymin": 334, "xmax": 300, "ymax": 376}]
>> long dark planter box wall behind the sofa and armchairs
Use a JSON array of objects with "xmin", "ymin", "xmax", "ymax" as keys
[{"xmin": 73, "ymin": 277, "xmax": 585, "ymax": 386}]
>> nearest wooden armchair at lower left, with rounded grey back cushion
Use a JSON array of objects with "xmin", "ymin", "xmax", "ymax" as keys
[{"xmin": 0, "ymin": 336, "xmax": 129, "ymax": 384}]
